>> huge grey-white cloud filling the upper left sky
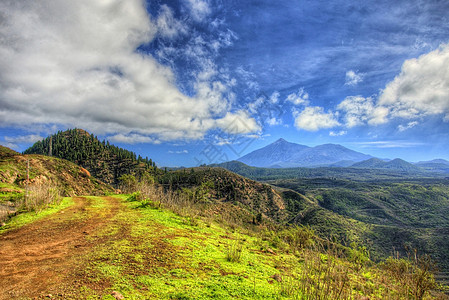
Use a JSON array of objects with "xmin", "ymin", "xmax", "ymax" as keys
[{"xmin": 0, "ymin": 0, "xmax": 257, "ymax": 142}]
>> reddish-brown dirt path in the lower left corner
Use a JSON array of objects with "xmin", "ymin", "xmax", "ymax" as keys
[{"xmin": 0, "ymin": 197, "xmax": 120, "ymax": 299}]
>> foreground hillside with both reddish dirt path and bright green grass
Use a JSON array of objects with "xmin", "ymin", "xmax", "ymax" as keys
[{"xmin": 0, "ymin": 195, "xmax": 445, "ymax": 300}]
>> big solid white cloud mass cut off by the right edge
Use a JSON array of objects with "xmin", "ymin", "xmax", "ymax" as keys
[{"xmin": 379, "ymin": 44, "xmax": 449, "ymax": 119}]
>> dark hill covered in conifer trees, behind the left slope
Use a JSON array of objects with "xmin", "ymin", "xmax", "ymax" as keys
[{"xmin": 24, "ymin": 129, "xmax": 156, "ymax": 186}]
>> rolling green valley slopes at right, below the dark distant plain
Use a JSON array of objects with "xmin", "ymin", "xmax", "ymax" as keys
[{"xmin": 274, "ymin": 178, "xmax": 449, "ymax": 272}]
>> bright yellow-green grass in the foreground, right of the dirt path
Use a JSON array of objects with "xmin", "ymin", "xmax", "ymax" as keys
[{"xmin": 69, "ymin": 196, "xmax": 444, "ymax": 299}]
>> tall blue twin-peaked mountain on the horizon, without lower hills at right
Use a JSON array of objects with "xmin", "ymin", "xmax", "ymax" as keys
[{"xmin": 238, "ymin": 139, "xmax": 371, "ymax": 168}]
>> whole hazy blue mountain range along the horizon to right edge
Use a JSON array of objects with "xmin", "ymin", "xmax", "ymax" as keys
[{"xmin": 237, "ymin": 138, "xmax": 449, "ymax": 173}]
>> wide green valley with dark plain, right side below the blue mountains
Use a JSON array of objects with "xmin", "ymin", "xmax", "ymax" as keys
[{"xmin": 212, "ymin": 160, "xmax": 449, "ymax": 272}]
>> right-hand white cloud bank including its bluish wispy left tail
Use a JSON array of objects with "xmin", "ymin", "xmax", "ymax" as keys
[{"xmin": 330, "ymin": 45, "xmax": 449, "ymax": 132}]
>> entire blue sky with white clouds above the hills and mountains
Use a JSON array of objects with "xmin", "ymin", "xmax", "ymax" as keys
[{"xmin": 0, "ymin": 0, "xmax": 449, "ymax": 167}]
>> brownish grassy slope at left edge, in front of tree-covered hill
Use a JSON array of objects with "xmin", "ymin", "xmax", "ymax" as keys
[{"xmin": 0, "ymin": 146, "xmax": 114, "ymax": 222}]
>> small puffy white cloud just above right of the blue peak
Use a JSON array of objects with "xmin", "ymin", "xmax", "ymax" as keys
[{"xmin": 294, "ymin": 106, "xmax": 340, "ymax": 131}]
